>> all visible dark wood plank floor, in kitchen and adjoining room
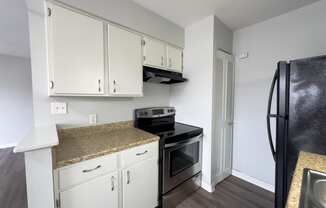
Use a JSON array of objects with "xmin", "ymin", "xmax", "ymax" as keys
[{"xmin": 0, "ymin": 148, "xmax": 274, "ymax": 208}]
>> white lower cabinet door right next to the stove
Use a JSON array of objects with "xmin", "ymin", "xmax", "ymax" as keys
[{"xmin": 122, "ymin": 158, "xmax": 158, "ymax": 208}]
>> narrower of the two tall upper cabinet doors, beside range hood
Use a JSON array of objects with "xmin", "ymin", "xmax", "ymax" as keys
[{"xmin": 108, "ymin": 25, "xmax": 143, "ymax": 96}]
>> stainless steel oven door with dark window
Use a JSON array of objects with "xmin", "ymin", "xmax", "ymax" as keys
[{"xmin": 163, "ymin": 135, "xmax": 203, "ymax": 194}]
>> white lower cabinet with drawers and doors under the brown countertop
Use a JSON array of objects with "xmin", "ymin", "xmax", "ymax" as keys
[{"xmin": 54, "ymin": 142, "xmax": 158, "ymax": 208}]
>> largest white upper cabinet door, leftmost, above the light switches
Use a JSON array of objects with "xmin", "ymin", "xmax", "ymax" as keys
[{"xmin": 48, "ymin": 5, "xmax": 104, "ymax": 94}]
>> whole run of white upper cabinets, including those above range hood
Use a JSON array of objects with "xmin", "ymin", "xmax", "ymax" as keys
[{"xmin": 47, "ymin": 3, "xmax": 182, "ymax": 97}]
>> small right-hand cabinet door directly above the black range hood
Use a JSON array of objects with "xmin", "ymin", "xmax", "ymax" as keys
[{"xmin": 167, "ymin": 45, "xmax": 183, "ymax": 72}]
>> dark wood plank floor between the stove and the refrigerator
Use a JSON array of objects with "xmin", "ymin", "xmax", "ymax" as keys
[{"xmin": 177, "ymin": 176, "xmax": 274, "ymax": 208}]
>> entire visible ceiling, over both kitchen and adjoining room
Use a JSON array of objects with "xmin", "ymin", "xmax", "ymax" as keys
[{"xmin": 0, "ymin": 0, "xmax": 318, "ymax": 57}]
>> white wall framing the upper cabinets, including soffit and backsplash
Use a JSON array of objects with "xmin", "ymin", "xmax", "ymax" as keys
[{"xmin": 27, "ymin": 0, "xmax": 184, "ymax": 125}]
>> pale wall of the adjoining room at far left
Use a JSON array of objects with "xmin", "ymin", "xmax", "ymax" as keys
[{"xmin": 0, "ymin": 55, "xmax": 33, "ymax": 148}]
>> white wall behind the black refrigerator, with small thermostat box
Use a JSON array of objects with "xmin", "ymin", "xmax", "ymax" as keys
[{"xmin": 233, "ymin": 1, "xmax": 326, "ymax": 185}]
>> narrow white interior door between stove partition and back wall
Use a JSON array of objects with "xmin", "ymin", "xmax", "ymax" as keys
[{"xmin": 216, "ymin": 51, "xmax": 234, "ymax": 181}]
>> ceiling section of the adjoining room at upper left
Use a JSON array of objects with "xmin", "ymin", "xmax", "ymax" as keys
[{"xmin": 0, "ymin": 0, "xmax": 29, "ymax": 57}]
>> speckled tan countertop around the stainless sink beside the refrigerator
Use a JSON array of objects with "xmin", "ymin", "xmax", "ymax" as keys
[{"xmin": 287, "ymin": 152, "xmax": 326, "ymax": 208}]
